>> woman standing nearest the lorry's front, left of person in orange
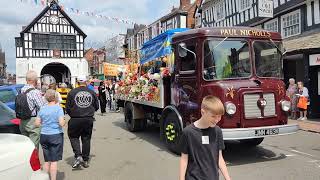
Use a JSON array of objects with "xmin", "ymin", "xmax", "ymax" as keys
[{"xmin": 286, "ymin": 78, "xmax": 298, "ymax": 119}]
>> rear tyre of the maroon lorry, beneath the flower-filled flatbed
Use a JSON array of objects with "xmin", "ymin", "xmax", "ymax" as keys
[{"xmin": 124, "ymin": 103, "xmax": 147, "ymax": 132}]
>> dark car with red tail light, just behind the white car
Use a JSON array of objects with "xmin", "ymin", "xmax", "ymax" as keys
[{"xmin": 0, "ymin": 102, "xmax": 20, "ymax": 134}]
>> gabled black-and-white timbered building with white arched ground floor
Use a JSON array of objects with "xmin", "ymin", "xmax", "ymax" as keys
[{"xmin": 15, "ymin": 0, "xmax": 88, "ymax": 84}]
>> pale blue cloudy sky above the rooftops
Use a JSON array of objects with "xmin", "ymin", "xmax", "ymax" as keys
[{"xmin": 0, "ymin": 0, "xmax": 180, "ymax": 73}]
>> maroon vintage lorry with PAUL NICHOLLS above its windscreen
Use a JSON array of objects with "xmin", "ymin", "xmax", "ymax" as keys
[{"xmin": 117, "ymin": 27, "xmax": 298, "ymax": 152}]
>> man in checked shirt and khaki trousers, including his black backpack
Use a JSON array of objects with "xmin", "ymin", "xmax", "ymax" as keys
[{"xmin": 16, "ymin": 70, "xmax": 46, "ymax": 149}]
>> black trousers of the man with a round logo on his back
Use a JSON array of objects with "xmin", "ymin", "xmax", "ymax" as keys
[{"xmin": 68, "ymin": 117, "xmax": 94, "ymax": 161}]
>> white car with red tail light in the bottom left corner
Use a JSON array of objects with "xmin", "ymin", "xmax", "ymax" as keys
[{"xmin": 0, "ymin": 133, "xmax": 49, "ymax": 180}]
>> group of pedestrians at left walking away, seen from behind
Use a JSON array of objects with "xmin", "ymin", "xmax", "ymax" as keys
[{"xmin": 16, "ymin": 71, "xmax": 99, "ymax": 180}]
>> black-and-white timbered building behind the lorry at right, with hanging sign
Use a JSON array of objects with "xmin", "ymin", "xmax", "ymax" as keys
[{"xmin": 194, "ymin": 0, "xmax": 320, "ymax": 117}]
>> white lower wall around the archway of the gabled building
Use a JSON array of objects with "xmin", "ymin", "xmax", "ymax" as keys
[{"xmin": 16, "ymin": 58, "xmax": 89, "ymax": 84}]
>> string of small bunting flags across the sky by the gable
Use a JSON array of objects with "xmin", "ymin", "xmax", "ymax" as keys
[{"xmin": 16, "ymin": 0, "xmax": 135, "ymax": 25}]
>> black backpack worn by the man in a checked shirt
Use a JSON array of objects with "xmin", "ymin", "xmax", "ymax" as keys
[{"xmin": 15, "ymin": 88, "xmax": 34, "ymax": 119}]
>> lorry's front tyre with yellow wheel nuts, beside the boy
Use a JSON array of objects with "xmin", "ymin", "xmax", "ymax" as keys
[{"xmin": 162, "ymin": 112, "xmax": 182, "ymax": 154}]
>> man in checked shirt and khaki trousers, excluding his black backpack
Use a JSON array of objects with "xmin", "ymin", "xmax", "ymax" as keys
[{"xmin": 20, "ymin": 70, "xmax": 46, "ymax": 149}]
